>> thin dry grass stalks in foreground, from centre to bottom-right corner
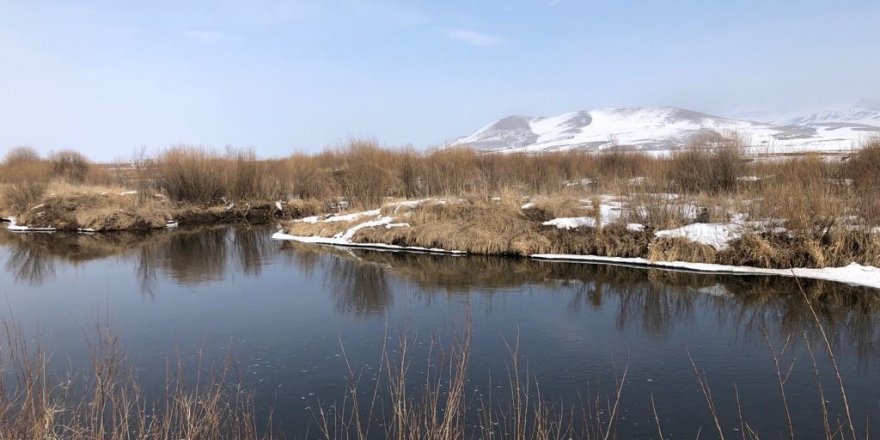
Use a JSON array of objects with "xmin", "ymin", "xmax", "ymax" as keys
[{"xmin": 315, "ymin": 280, "xmax": 871, "ymax": 440}]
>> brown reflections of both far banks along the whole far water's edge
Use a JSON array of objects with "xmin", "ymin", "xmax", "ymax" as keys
[{"xmin": 0, "ymin": 227, "xmax": 880, "ymax": 359}]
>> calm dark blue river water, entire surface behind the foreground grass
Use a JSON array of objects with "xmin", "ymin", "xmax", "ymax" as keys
[{"xmin": 0, "ymin": 227, "xmax": 880, "ymax": 438}]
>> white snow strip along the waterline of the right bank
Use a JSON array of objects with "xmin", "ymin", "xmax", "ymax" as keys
[{"xmin": 530, "ymin": 254, "xmax": 880, "ymax": 289}]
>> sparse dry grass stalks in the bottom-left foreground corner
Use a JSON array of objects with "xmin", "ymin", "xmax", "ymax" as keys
[{"xmin": 0, "ymin": 322, "xmax": 261, "ymax": 440}]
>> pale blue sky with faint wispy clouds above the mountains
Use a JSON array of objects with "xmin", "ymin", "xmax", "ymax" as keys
[{"xmin": 0, "ymin": 0, "xmax": 880, "ymax": 160}]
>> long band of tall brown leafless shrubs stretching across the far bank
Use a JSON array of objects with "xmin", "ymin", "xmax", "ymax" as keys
[{"xmin": 6, "ymin": 134, "xmax": 880, "ymax": 240}]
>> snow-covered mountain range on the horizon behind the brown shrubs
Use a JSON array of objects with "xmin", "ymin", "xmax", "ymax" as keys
[{"xmin": 453, "ymin": 107, "xmax": 880, "ymax": 153}]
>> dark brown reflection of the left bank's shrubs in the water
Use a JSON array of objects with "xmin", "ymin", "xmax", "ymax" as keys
[{"xmin": 0, "ymin": 226, "xmax": 279, "ymax": 294}]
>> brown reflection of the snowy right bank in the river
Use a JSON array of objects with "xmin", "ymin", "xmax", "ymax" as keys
[{"xmin": 284, "ymin": 244, "xmax": 880, "ymax": 359}]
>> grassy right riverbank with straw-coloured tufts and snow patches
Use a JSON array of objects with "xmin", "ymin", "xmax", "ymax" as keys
[{"xmin": 273, "ymin": 199, "xmax": 880, "ymax": 288}]
